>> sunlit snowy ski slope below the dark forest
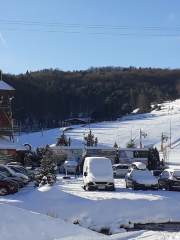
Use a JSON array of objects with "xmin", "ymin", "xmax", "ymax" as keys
[{"xmin": 17, "ymin": 99, "xmax": 180, "ymax": 166}]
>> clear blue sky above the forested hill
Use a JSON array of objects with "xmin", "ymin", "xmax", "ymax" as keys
[{"xmin": 0, "ymin": 0, "xmax": 180, "ymax": 74}]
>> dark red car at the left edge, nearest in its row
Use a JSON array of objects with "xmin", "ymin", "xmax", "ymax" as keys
[{"xmin": 0, "ymin": 173, "xmax": 19, "ymax": 196}]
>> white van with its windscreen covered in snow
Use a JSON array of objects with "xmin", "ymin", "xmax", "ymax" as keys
[{"xmin": 83, "ymin": 157, "xmax": 115, "ymax": 191}]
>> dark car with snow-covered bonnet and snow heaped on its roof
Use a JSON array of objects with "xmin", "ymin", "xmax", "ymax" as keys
[{"xmin": 125, "ymin": 162, "xmax": 158, "ymax": 190}]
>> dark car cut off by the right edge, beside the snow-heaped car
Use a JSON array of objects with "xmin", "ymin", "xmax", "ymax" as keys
[{"xmin": 158, "ymin": 168, "xmax": 180, "ymax": 191}]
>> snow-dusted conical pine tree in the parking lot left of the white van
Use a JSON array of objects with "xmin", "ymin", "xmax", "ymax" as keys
[{"xmin": 35, "ymin": 144, "xmax": 57, "ymax": 186}]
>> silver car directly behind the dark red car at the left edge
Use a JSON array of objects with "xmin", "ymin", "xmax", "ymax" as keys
[{"xmin": 0, "ymin": 164, "xmax": 30, "ymax": 184}]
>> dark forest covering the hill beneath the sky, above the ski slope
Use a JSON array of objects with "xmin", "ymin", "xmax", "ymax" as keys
[{"xmin": 3, "ymin": 66, "xmax": 180, "ymax": 129}]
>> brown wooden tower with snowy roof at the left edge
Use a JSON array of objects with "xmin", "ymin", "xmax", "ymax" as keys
[{"xmin": 0, "ymin": 70, "xmax": 15, "ymax": 142}]
